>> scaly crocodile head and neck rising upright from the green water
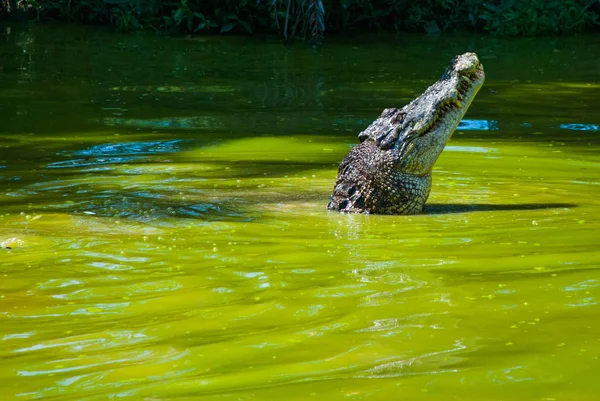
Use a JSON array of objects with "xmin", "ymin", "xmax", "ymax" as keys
[{"xmin": 327, "ymin": 53, "xmax": 485, "ymax": 214}]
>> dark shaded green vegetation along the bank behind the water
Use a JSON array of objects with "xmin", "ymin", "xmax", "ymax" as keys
[{"xmin": 0, "ymin": 0, "xmax": 600, "ymax": 44}]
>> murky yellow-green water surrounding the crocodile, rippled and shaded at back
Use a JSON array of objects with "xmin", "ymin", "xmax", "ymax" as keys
[{"xmin": 0, "ymin": 25, "xmax": 600, "ymax": 401}]
